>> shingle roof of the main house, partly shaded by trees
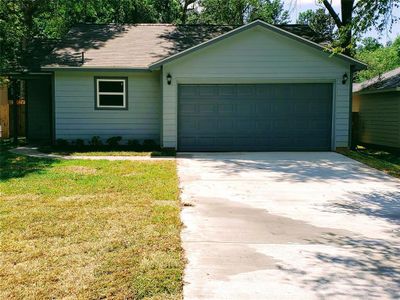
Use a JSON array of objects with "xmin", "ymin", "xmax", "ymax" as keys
[{"xmin": 43, "ymin": 24, "xmax": 324, "ymax": 68}]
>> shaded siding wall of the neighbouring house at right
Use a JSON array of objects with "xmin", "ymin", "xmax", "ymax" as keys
[{"xmin": 359, "ymin": 92, "xmax": 400, "ymax": 148}]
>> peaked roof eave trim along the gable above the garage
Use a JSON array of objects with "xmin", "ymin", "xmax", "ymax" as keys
[{"xmin": 149, "ymin": 20, "xmax": 368, "ymax": 71}]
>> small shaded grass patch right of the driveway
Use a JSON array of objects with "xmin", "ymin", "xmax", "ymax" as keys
[{"xmin": 338, "ymin": 147, "xmax": 400, "ymax": 178}]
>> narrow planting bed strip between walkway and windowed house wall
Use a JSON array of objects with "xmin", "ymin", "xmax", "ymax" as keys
[{"xmin": 38, "ymin": 146, "xmax": 176, "ymax": 157}]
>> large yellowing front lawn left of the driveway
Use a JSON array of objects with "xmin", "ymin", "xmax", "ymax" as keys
[{"xmin": 0, "ymin": 151, "xmax": 184, "ymax": 299}]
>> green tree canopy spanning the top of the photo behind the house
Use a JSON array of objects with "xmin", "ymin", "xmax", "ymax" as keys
[{"xmin": 0, "ymin": 0, "xmax": 400, "ymax": 72}]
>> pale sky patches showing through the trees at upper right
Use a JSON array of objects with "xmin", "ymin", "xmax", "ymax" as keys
[{"xmin": 284, "ymin": 0, "xmax": 400, "ymax": 44}]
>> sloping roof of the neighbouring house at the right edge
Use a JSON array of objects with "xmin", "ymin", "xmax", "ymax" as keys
[{"xmin": 353, "ymin": 68, "xmax": 400, "ymax": 92}]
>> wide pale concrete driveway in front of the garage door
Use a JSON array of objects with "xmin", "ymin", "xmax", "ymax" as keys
[{"xmin": 178, "ymin": 153, "xmax": 400, "ymax": 299}]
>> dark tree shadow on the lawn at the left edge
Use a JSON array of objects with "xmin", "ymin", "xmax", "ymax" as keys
[{"xmin": 0, "ymin": 150, "xmax": 59, "ymax": 181}]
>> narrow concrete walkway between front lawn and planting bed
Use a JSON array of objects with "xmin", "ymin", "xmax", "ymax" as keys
[{"xmin": 10, "ymin": 147, "xmax": 175, "ymax": 161}]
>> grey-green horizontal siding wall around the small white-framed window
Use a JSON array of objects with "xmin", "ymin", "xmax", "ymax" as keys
[{"xmin": 55, "ymin": 71, "xmax": 161, "ymax": 142}]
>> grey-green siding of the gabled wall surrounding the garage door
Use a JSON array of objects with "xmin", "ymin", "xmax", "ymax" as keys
[{"xmin": 162, "ymin": 27, "xmax": 350, "ymax": 148}]
